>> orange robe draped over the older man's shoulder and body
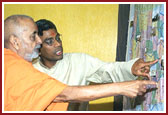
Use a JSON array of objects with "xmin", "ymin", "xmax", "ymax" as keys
[{"xmin": 4, "ymin": 49, "xmax": 68, "ymax": 111}]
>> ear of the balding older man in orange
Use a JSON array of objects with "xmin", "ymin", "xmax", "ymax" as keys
[{"xmin": 9, "ymin": 35, "xmax": 20, "ymax": 50}]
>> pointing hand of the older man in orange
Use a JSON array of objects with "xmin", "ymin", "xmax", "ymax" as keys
[{"xmin": 119, "ymin": 80, "xmax": 157, "ymax": 98}]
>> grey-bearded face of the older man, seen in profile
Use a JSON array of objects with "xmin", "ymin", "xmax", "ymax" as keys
[{"xmin": 19, "ymin": 19, "xmax": 41, "ymax": 61}]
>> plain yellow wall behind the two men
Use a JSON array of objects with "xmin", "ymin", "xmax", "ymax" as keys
[{"xmin": 4, "ymin": 4, "xmax": 118, "ymax": 110}]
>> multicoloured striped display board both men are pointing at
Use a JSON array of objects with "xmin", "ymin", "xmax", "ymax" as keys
[{"xmin": 123, "ymin": 4, "xmax": 166, "ymax": 111}]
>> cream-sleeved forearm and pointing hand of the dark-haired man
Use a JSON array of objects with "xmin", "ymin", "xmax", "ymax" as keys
[{"xmin": 87, "ymin": 58, "xmax": 158, "ymax": 83}]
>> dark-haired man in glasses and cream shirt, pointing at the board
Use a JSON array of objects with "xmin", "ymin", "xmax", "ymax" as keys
[{"xmin": 33, "ymin": 19, "xmax": 156, "ymax": 111}]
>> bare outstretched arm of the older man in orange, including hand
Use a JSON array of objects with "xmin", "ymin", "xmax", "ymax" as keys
[{"xmin": 54, "ymin": 80, "xmax": 157, "ymax": 102}]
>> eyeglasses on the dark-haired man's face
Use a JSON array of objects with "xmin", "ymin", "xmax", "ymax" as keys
[{"xmin": 43, "ymin": 34, "xmax": 62, "ymax": 46}]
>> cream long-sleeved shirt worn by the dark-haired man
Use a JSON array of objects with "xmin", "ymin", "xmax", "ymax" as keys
[{"xmin": 33, "ymin": 53, "xmax": 137, "ymax": 110}]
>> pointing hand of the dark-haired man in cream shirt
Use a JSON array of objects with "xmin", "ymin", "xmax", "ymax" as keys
[{"xmin": 131, "ymin": 59, "xmax": 158, "ymax": 79}]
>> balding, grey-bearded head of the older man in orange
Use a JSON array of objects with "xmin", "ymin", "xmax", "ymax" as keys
[{"xmin": 4, "ymin": 15, "xmax": 41, "ymax": 61}]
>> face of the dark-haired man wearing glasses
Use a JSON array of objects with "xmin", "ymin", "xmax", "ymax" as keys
[{"xmin": 40, "ymin": 29, "xmax": 63, "ymax": 61}]
